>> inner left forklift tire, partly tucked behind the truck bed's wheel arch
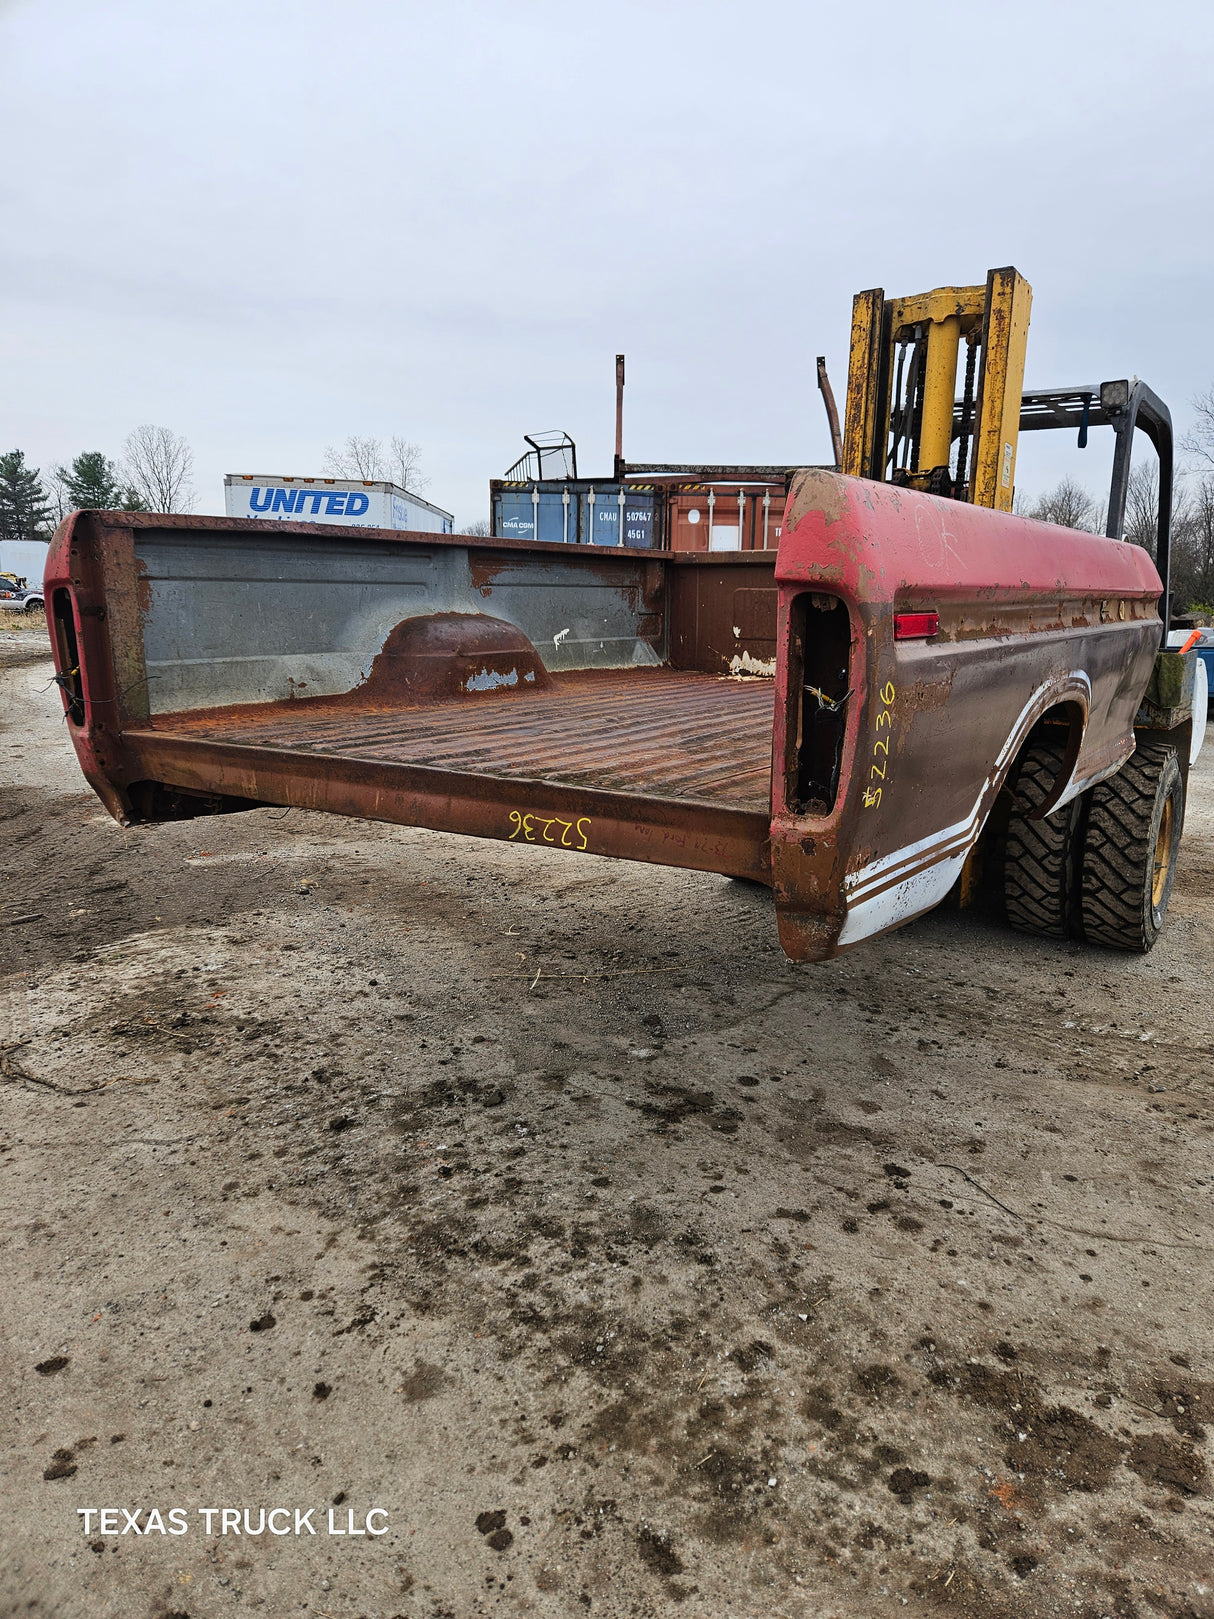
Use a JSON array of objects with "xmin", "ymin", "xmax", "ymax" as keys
[{"xmin": 1004, "ymin": 742, "xmax": 1078, "ymax": 939}]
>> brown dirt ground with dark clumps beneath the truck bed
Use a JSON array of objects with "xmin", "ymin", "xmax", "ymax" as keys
[{"xmin": 0, "ymin": 608, "xmax": 1214, "ymax": 1619}]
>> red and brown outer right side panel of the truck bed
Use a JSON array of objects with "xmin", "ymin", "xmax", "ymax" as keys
[{"xmin": 772, "ymin": 471, "xmax": 1161, "ymax": 960}]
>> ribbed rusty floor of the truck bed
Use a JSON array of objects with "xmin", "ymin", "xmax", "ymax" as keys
[{"xmin": 151, "ymin": 669, "xmax": 774, "ymax": 813}]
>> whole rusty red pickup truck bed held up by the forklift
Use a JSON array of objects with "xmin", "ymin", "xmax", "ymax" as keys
[{"xmin": 47, "ymin": 470, "xmax": 1162, "ymax": 960}]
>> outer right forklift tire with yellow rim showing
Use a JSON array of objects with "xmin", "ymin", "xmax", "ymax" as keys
[{"xmin": 1080, "ymin": 742, "xmax": 1185, "ymax": 954}]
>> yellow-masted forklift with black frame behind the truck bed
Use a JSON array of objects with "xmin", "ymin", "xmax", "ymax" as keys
[{"xmin": 819, "ymin": 267, "xmax": 1206, "ymax": 952}]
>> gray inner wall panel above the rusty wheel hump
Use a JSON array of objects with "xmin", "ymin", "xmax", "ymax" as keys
[{"xmin": 136, "ymin": 529, "xmax": 665, "ymax": 714}]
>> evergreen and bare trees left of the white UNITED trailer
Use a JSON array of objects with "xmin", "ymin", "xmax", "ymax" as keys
[{"xmin": 0, "ymin": 424, "xmax": 194, "ymax": 539}]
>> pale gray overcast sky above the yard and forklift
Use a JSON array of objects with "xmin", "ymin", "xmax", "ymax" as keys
[{"xmin": 0, "ymin": 0, "xmax": 1214, "ymax": 523}]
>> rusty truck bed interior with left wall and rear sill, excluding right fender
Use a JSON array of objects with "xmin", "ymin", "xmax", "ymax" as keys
[{"xmin": 49, "ymin": 513, "xmax": 777, "ymax": 881}]
